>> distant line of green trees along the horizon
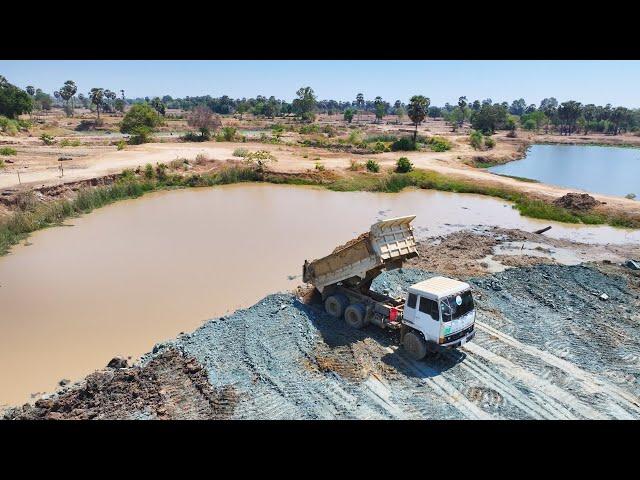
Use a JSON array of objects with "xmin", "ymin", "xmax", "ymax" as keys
[{"xmin": 0, "ymin": 76, "xmax": 640, "ymax": 135}]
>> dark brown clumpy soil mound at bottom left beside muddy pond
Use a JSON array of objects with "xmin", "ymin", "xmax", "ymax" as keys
[{"xmin": 6, "ymin": 350, "xmax": 238, "ymax": 420}]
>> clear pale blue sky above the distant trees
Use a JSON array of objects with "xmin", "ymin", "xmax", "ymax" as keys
[{"xmin": 0, "ymin": 60, "xmax": 640, "ymax": 108}]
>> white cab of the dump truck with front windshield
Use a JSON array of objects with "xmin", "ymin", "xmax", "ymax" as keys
[{"xmin": 403, "ymin": 277, "xmax": 476, "ymax": 347}]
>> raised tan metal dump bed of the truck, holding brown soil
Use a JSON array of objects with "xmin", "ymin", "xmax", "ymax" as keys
[{"xmin": 302, "ymin": 215, "xmax": 418, "ymax": 292}]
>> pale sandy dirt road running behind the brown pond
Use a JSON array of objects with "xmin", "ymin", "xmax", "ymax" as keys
[{"xmin": 0, "ymin": 137, "xmax": 640, "ymax": 216}]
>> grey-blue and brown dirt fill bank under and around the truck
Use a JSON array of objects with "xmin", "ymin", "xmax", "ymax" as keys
[{"xmin": 5, "ymin": 229, "xmax": 640, "ymax": 419}]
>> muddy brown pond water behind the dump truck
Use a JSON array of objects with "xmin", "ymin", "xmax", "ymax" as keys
[{"xmin": 0, "ymin": 184, "xmax": 640, "ymax": 404}]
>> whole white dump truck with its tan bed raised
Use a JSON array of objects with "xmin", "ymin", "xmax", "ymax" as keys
[{"xmin": 302, "ymin": 215, "xmax": 476, "ymax": 360}]
